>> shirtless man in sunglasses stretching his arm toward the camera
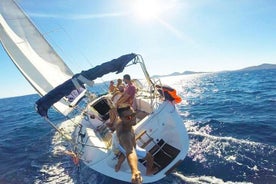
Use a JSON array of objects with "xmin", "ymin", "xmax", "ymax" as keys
[{"xmin": 115, "ymin": 105, "xmax": 154, "ymax": 183}]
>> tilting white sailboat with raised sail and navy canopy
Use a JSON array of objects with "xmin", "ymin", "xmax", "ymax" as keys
[{"xmin": 0, "ymin": 0, "xmax": 189, "ymax": 183}]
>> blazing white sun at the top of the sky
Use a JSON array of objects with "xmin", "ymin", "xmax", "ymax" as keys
[{"xmin": 133, "ymin": 0, "xmax": 165, "ymax": 21}]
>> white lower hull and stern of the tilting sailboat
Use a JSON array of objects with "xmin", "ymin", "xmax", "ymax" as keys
[{"xmin": 73, "ymin": 97, "xmax": 189, "ymax": 183}]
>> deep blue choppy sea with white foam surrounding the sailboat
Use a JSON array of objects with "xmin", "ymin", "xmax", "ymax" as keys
[{"xmin": 0, "ymin": 69, "xmax": 276, "ymax": 184}]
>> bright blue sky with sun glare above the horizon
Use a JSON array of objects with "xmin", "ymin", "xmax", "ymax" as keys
[{"xmin": 0, "ymin": 0, "xmax": 276, "ymax": 98}]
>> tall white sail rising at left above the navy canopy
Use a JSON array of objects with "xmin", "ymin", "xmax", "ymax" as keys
[{"xmin": 0, "ymin": 0, "xmax": 73, "ymax": 115}]
